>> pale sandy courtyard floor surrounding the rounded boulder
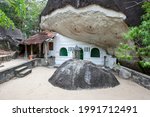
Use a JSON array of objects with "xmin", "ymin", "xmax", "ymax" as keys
[{"xmin": 0, "ymin": 67, "xmax": 150, "ymax": 100}]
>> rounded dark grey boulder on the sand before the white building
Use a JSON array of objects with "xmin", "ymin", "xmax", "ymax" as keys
[{"xmin": 49, "ymin": 60, "xmax": 119, "ymax": 90}]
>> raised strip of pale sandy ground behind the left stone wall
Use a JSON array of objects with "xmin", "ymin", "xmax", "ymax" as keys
[{"xmin": 0, "ymin": 59, "xmax": 29, "ymax": 71}]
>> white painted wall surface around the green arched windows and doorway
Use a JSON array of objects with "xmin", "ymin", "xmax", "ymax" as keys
[{"xmin": 49, "ymin": 34, "xmax": 116, "ymax": 68}]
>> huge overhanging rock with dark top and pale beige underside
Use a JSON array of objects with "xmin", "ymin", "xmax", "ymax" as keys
[{"xmin": 40, "ymin": 0, "xmax": 142, "ymax": 50}]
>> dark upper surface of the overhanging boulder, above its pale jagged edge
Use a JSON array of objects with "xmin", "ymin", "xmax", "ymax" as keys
[{"xmin": 41, "ymin": 0, "xmax": 144, "ymax": 26}]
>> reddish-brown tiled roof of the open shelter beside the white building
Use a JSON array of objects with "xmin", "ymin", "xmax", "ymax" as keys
[{"xmin": 21, "ymin": 31, "xmax": 56, "ymax": 45}]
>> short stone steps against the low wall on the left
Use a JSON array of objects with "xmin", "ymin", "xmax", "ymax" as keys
[{"xmin": 15, "ymin": 66, "xmax": 32, "ymax": 78}]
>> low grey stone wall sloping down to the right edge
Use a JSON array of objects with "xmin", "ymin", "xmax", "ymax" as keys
[{"xmin": 114, "ymin": 66, "xmax": 150, "ymax": 90}]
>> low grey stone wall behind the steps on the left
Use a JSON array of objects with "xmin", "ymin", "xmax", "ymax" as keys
[{"xmin": 0, "ymin": 59, "xmax": 41, "ymax": 83}]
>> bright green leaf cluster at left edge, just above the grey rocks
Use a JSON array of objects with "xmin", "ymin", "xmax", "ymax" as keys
[{"xmin": 0, "ymin": 9, "xmax": 14, "ymax": 28}]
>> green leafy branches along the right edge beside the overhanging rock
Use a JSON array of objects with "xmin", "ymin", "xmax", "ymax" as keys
[{"xmin": 118, "ymin": 2, "xmax": 150, "ymax": 68}]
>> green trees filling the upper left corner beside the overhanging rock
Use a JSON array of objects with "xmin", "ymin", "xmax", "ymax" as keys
[{"xmin": 0, "ymin": 0, "xmax": 47, "ymax": 36}]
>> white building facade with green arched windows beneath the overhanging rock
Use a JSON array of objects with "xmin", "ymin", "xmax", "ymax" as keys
[{"xmin": 48, "ymin": 33, "xmax": 116, "ymax": 68}]
